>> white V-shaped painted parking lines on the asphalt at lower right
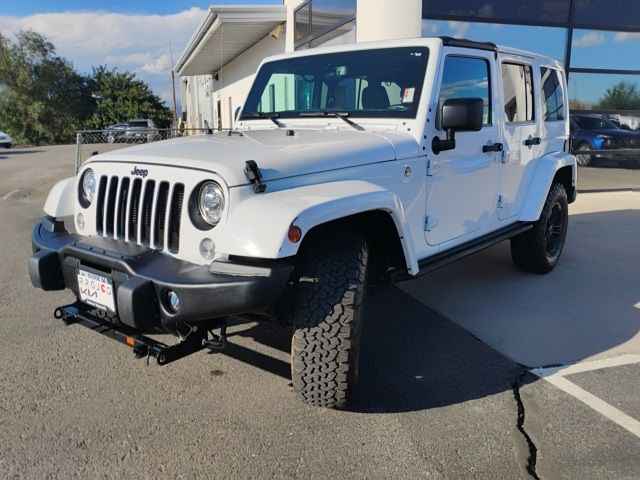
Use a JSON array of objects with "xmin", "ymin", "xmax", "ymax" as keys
[{"xmin": 531, "ymin": 354, "xmax": 640, "ymax": 438}]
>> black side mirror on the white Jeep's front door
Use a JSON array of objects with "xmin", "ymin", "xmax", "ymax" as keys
[{"xmin": 431, "ymin": 98, "xmax": 484, "ymax": 155}]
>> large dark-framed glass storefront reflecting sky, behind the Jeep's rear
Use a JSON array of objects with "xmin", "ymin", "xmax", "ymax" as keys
[{"xmin": 422, "ymin": 0, "xmax": 640, "ymax": 191}]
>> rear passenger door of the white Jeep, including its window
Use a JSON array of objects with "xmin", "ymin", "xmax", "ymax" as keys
[{"xmin": 498, "ymin": 55, "xmax": 541, "ymax": 220}]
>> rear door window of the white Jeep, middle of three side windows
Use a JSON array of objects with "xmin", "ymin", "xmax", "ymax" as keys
[{"xmin": 502, "ymin": 63, "xmax": 534, "ymax": 123}]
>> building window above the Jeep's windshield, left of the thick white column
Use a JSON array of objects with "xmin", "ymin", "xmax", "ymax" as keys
[{"xmin": 294, "ymin": 0, "xmax": 357, "ymax": 49}]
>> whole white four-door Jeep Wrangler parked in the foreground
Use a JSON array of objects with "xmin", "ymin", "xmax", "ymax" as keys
[{"xmin": 29, "ymin": 38, "xmax": 576, "ymax": 408}]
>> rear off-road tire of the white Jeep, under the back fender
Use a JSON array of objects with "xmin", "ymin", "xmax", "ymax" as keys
[{"xmin": 511, "ymin": 183, "xmax": 569, "ymax": 274}]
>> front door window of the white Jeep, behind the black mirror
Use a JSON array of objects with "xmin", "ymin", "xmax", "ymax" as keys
[{"xmin": 437, "ymin": 55, "xmax": 491, "ymax": 125}]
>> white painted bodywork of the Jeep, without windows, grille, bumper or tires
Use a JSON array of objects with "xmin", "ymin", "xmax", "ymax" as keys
[{"xmin": 45, "ymin": 39, "xmax": 576, "ymax": 274}]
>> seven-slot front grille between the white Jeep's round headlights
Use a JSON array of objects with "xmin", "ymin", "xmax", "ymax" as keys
[{"xmin": 96, "ymin": 175, "xmax": 184, "ymax": 253}]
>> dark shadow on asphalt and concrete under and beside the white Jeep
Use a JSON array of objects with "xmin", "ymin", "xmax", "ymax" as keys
[{"xmin": 218, "ymin": 210, "xmax": 640, "ymax": 413}]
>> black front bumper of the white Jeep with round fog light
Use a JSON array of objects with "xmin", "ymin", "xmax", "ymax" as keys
[{"xmin": 29, "ymin": 217, "xmax": 293, "ymax": 333}]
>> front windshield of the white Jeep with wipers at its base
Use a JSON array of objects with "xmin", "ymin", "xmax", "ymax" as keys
[{"xmin": 241, "ymin": 47, "xmax": 428, "ymax": 120}]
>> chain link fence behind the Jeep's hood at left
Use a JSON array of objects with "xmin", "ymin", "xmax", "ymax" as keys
[{"xmin": 76, "ymin": 127, "xmax": 220, "ymax": 173}]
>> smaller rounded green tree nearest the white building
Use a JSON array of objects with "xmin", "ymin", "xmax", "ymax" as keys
[{"xmin": 88, "ymin": 66, "xmax": 173, "ymax": 129}]
